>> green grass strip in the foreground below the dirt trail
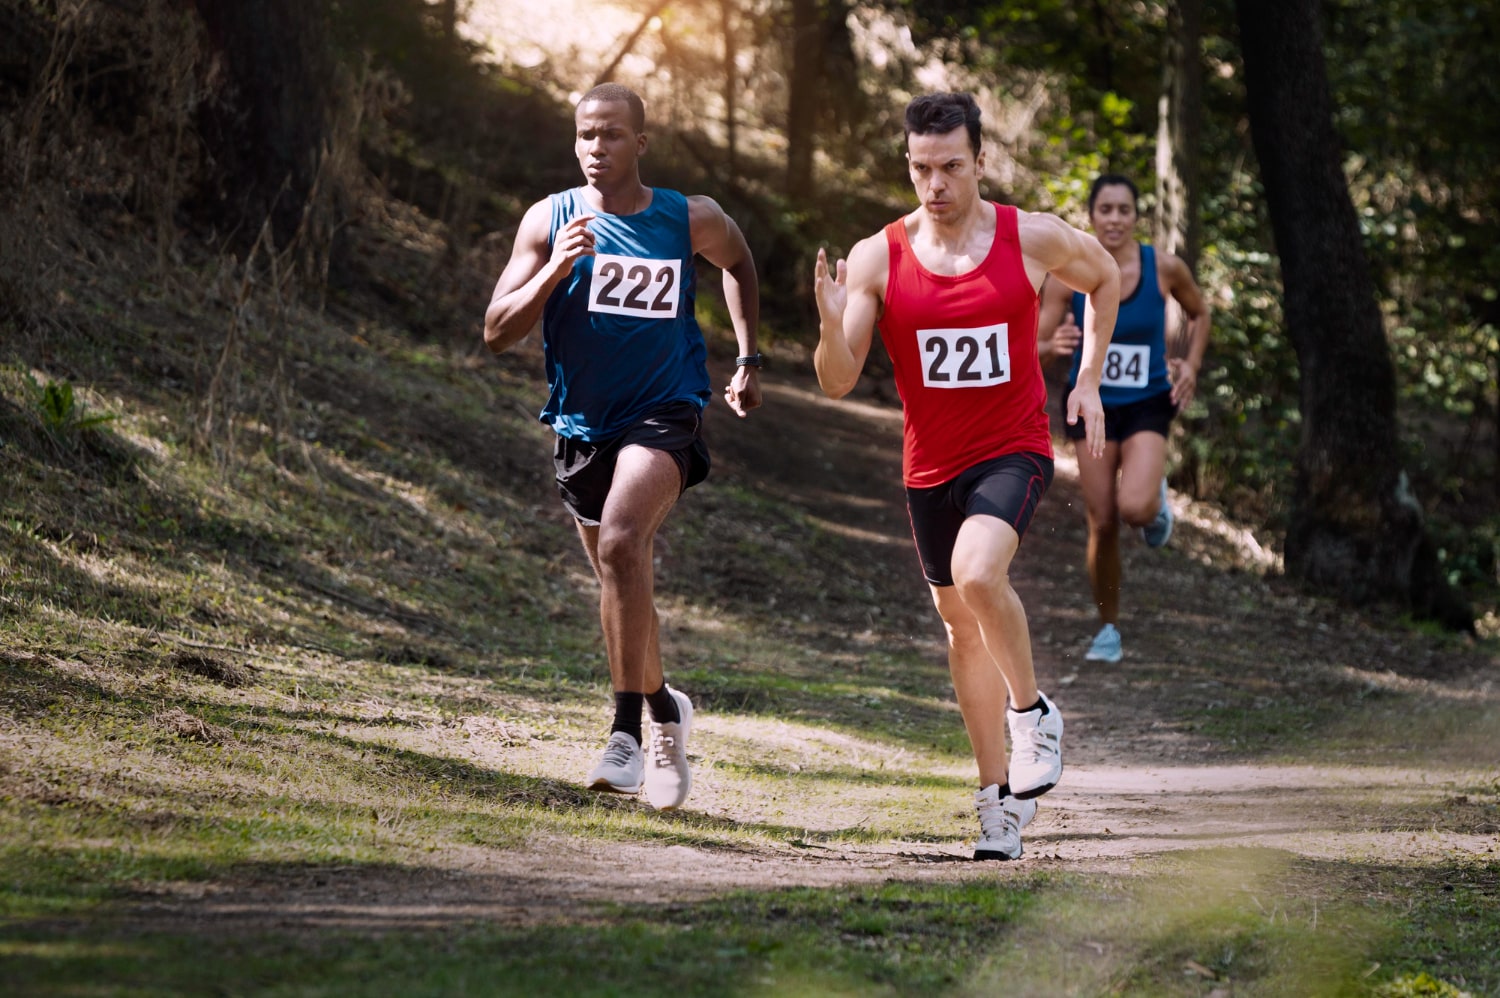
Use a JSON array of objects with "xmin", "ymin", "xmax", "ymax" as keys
[{"xmin": 0, "ymin": 851, "xmax": 1500, "ymax": 996}]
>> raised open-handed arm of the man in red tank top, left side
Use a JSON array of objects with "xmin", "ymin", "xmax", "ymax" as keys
[{"xmin": 813, "ymin": 234, "xmax": 890, "ymax": 399}]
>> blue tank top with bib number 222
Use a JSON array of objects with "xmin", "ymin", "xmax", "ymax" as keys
[{"xmin": 542, "ymin": 188, "xmax": 710, "ymax": 440}]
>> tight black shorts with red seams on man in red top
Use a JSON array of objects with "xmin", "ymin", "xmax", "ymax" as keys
[{"xmin": 906, "ymin": 453, "xmax": 1052, "ymax": 585}]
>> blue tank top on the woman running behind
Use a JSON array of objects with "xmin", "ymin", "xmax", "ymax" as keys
[{"xmin": 1068, "ymin": 245, "xmax": 1172, "ymax": 407}]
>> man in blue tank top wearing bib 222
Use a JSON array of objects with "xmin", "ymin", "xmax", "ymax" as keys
[{"xmin": 485, "ymin": 84, "xmax": 761, "ymax": 807}]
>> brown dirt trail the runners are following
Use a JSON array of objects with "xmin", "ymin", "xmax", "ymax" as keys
[{"xmin": 108, "ymin": 371, "xmax": 1500, "ymax": 930}]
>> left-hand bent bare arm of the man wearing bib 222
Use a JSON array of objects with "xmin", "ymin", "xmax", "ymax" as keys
[{"xmin": 485, "ymin": 201, "xmax": 594, "ymax": 353}]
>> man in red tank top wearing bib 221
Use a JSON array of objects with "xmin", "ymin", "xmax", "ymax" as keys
[{"xmin": 813, "ymin": 93, "xmax": 1119, "ymax": 860}]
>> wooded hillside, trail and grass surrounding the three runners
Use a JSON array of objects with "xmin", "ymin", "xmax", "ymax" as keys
[{"xmin": 0, "ymin": 0, "xmax": 1500, "ymax": 995}]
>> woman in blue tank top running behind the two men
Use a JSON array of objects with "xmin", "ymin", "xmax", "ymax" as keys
[{"xmin": 1037, "ymin": 174, "xmax": 1209, "ymax": 662}]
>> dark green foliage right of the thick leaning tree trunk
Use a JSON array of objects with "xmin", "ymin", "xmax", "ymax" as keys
[{"xmin": 1329, "ymin": 0, "xmax": 1500, "ymax": 600}]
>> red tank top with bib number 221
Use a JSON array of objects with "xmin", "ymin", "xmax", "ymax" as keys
[{"xmin": 881, "ymin": 204, "xmax": 1052, "ymax": 488}]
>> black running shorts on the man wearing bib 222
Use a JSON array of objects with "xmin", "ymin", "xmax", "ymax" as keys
[{"xmin": 552, "ymin": 402, "xmax": 710, "ymax": 527}]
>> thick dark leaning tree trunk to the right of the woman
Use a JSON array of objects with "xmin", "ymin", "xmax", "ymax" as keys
[{"xmin": 1236, "ymin": 0, "xmax": 1473, "ymax": 630}]
